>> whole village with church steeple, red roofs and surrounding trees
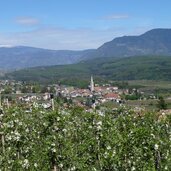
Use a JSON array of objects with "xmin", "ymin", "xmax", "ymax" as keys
[{"xmin": 0, "ymin": 76, "xmax": 162, "ymax": 109}]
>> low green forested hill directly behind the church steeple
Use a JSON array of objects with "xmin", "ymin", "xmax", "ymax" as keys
[{"xmin": 6, "ymin": 56, "xmax": 171, "ymax": 82}]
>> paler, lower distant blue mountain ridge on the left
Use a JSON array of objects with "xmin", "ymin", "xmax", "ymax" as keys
[{"xmin": 0, "ymin": 46, "xmax": 93, "ymax": 69}]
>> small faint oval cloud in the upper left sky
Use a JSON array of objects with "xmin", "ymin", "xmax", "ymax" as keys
[{"xmin": 15, "ymin": 17, "xmax": 39, "ymax": 26}]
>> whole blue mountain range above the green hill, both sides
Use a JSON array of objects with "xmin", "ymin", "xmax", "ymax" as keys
[{"xmin": 0, "ymin": 29, "xmax": 171, "ymax": 69}]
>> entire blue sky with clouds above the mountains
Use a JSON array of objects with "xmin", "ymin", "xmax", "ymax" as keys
[{"xmin": 0, "ymin": 0, "xmax": 171, "ymax": 50}]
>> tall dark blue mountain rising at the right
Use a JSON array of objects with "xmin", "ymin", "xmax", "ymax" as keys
[{"xmin": 85, "ymin": 29, "xmax": 171, "ymax": 59}]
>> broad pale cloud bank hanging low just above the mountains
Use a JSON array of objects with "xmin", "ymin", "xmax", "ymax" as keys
[{"xmin": 0, "ymin": 27, "xmax": 150, "ymax": 50}]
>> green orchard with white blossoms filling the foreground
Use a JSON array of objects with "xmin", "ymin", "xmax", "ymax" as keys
[{"xmin": 0, "ymin": 107, "xmax": 171, "ymax": 171}]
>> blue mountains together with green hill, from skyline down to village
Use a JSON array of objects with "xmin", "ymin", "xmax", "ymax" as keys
[{"xmin": 0, "ymin": 29, "xmax": 171, "ymax": 85}]
